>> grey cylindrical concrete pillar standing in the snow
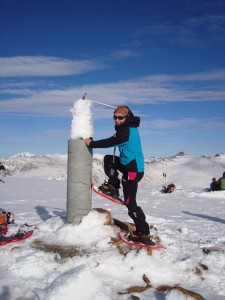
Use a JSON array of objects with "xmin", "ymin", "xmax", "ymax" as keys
[{"xmin": 67, "ymin": 139, "xmax": 92, "ymax": 225}]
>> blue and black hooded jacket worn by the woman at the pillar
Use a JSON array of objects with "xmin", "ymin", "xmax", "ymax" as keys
[{"xmin": 89, "ymin": 111, "xmax": 144, "ymax": 172}]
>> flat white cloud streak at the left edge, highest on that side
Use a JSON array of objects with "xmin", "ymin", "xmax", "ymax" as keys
[{"xmin": 0, "ymin": 56, "xmax": 103, "ymax": 77}]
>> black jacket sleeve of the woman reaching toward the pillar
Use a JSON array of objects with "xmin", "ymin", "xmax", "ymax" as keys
[{"xmin": 89, "ymin": 127, "xmax": 130, "ymax": 148}]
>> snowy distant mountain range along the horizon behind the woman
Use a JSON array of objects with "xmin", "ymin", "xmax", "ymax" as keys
[{"xmin": 1, "ymin": 152, "xmax": 225, "ymax": 187}]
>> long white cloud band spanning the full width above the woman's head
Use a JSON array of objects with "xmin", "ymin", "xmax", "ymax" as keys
[{"xmin": 0, "ymin": 70, "xmax": 225, "ymax": 117}]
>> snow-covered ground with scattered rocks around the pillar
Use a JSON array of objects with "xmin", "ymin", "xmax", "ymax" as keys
[{"xmin": 0, "ymin": 154, "xmax": 225, "ymax": 300}]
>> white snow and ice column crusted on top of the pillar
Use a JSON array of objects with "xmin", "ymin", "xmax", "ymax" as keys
[{"xmin": 70, "ymin": 99, "xmax": 94, "ymax": 140}]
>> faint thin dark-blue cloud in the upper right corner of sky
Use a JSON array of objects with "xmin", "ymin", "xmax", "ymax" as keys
[{"xmin": 133, "ymin": 13, "xmax": 225, "ymax": 47}]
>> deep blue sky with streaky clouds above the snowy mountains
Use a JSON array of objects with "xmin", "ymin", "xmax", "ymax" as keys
[{"xmin": 0, "ymin": 0, "xmax": 225, "ymax": 158}]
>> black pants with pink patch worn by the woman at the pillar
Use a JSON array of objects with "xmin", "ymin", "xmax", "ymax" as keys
[{"xmin": 104, "ymin": 155, "xmax": 149, "ymax": 234}]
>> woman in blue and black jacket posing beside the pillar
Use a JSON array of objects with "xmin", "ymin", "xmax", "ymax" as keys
[{"xmin": 85, "ymin": 106, "xmax": 155, "ymax": 245}]
